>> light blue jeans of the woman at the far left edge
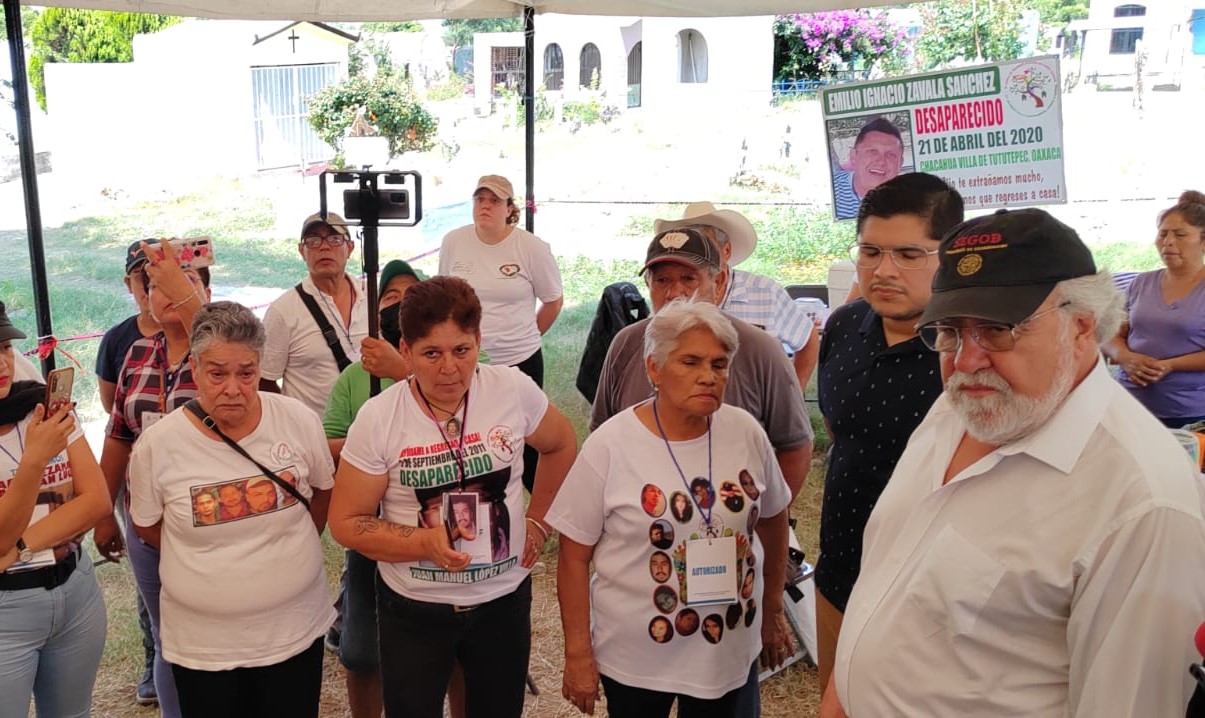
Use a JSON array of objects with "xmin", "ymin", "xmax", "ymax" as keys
[{"xmin": 0, "ymin": 554, "xmax": 108, "ymax": 718}]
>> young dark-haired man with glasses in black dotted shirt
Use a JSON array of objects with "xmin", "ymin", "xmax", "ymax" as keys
[{"xmin": 816, "ymin": 172, "xmax": 963, "ymax": 685}]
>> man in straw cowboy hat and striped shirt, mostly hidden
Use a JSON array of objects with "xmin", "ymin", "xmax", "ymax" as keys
[{"xmin": 653, "ymin": 202, "xmax": 821, "ymax": 389}]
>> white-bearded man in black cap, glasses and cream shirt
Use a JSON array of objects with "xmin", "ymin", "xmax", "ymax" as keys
[{"xmin": 819, "ymin": 210, "xmax": 1205, "ymax": 718}]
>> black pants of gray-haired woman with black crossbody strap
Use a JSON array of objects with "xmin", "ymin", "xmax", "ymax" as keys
[{"xmin": 171, "ymin": 637, "xmax": 322, "ymax": 718}]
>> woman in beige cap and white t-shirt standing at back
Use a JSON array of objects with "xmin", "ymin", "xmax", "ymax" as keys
[{"xmin": 440, "ymin": 175, "xmax": 564, "ymax": 492}]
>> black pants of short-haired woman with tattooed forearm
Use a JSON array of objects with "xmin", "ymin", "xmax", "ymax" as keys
[{"xmin": 377, "ymin": 575, "xmax": 530, "ymax": 718}]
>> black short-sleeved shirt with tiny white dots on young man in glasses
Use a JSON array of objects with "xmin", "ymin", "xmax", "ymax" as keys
[{"xmin": 816, "ymin": 300, "xmax": 941, "ymax": 612}]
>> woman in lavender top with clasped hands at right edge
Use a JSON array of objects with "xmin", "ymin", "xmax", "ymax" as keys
[{"xmin": 1104, "ymin": 190, "xmax": 1205, "ymax": 429}]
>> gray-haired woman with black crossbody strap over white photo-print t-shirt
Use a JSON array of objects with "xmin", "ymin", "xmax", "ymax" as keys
[{"xmin": 130, "ymin": 301, "xmax": 334, "ymax": 718}]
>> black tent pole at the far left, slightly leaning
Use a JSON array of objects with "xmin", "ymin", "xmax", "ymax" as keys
[{"xmin": 4, "ymin": 0, "xmax": 54, "ymax": 372}]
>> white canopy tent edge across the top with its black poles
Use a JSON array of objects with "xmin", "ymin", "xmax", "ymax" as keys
[{"xmin": 4, "ymin": 0, "xmax": 892, "ymax": 371}]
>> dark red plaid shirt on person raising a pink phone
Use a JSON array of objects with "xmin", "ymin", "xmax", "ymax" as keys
[{"xmin": 105, "ymin": 332, "xmax": 196, "ymax": 442}]
